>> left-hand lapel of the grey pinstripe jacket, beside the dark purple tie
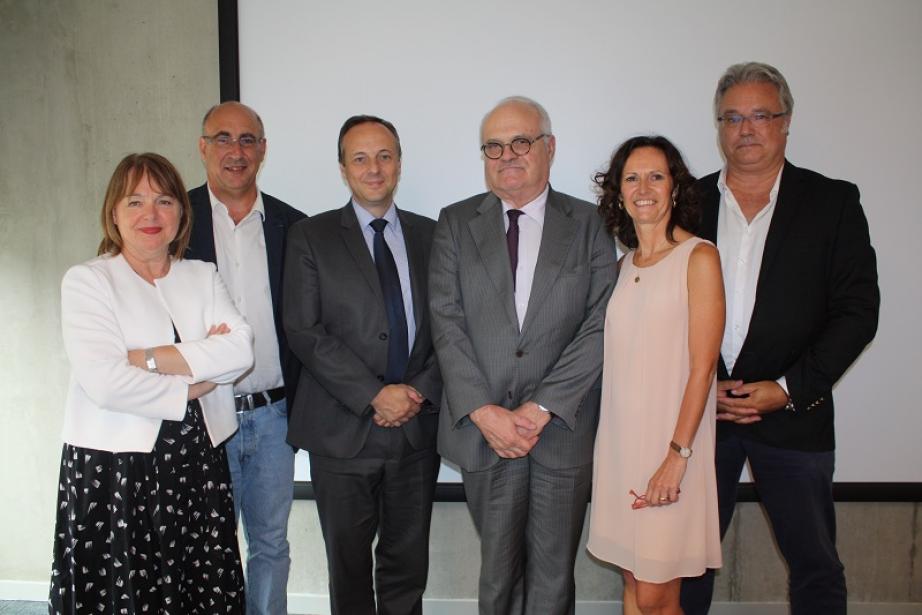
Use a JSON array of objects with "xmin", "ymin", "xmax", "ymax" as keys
[{"xmin": 468, "ymin": 192, "xmax": 519, "ymax": 329}]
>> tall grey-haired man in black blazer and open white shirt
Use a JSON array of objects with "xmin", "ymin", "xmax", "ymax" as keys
[{"xmin": 682, "ymin": 62, "xmax": 880, "ymax": 615}]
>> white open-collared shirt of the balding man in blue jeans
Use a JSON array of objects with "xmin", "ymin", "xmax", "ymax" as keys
[{"xmin": 208, "ymin": 187, "xmax": 284, "ymax": 395}]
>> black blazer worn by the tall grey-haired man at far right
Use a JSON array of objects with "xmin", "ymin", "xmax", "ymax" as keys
[{"xmin": 698, "ymin": 161, "xmax": 880, "ymax": 451}]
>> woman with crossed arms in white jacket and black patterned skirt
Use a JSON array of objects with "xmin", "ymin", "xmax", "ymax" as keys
[{"xmin": 49, "ymin": 154, "xmax": 253, "ymax": 614}]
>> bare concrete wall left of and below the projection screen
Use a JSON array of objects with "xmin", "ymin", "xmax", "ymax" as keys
[{"xmin": 0, "ymin": 0, "xmax": 922, "ymax": 612}]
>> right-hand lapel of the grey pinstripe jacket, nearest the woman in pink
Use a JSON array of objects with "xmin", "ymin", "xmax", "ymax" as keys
[{"xmin": 522, "ymin": 190, "xmax": 576, "ymax": 340}]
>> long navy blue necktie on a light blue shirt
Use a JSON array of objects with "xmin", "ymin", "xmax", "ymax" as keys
[{"xmin": 371, "ymin": 218, "xmax": 410, "ymax": 384}]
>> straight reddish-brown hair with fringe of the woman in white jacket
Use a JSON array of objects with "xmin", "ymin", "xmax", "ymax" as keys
[{"xmin": 97, "ymin": 152, "xmax": 192, "ymax": 259}]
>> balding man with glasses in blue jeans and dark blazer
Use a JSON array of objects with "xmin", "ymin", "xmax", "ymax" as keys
[{"xmin": 186, "ymin": 102, "xmax": 305, "ymax": 615}]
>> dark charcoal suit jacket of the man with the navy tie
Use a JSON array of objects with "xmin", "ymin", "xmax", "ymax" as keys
[{"xmin": 283, "ymin": 203, "xmax": 442, "ymax": 459}]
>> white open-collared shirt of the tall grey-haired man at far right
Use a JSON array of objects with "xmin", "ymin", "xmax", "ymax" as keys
[{"xmin": 717, "ymin": 168, "xmax": 787, "ymax": 391}]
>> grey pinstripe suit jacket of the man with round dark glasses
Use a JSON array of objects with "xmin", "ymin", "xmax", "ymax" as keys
[{"xmin": 429, "ymin": 190, "xmax": 617, "ymax": 471}]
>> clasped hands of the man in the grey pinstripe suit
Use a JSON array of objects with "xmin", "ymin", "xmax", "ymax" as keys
[{"xmin": 469, "ymin": 401, "xmax": 551, "ymax": 459}]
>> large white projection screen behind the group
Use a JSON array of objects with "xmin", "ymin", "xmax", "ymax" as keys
[{"xmin": 234, "ymin": 0, "xmax": 922, "ymax": 493}]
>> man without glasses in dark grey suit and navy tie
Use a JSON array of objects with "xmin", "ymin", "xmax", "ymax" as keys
[{"xmin": 284, "ymin": 115, "xmax": 442, "ymax": 615}]
